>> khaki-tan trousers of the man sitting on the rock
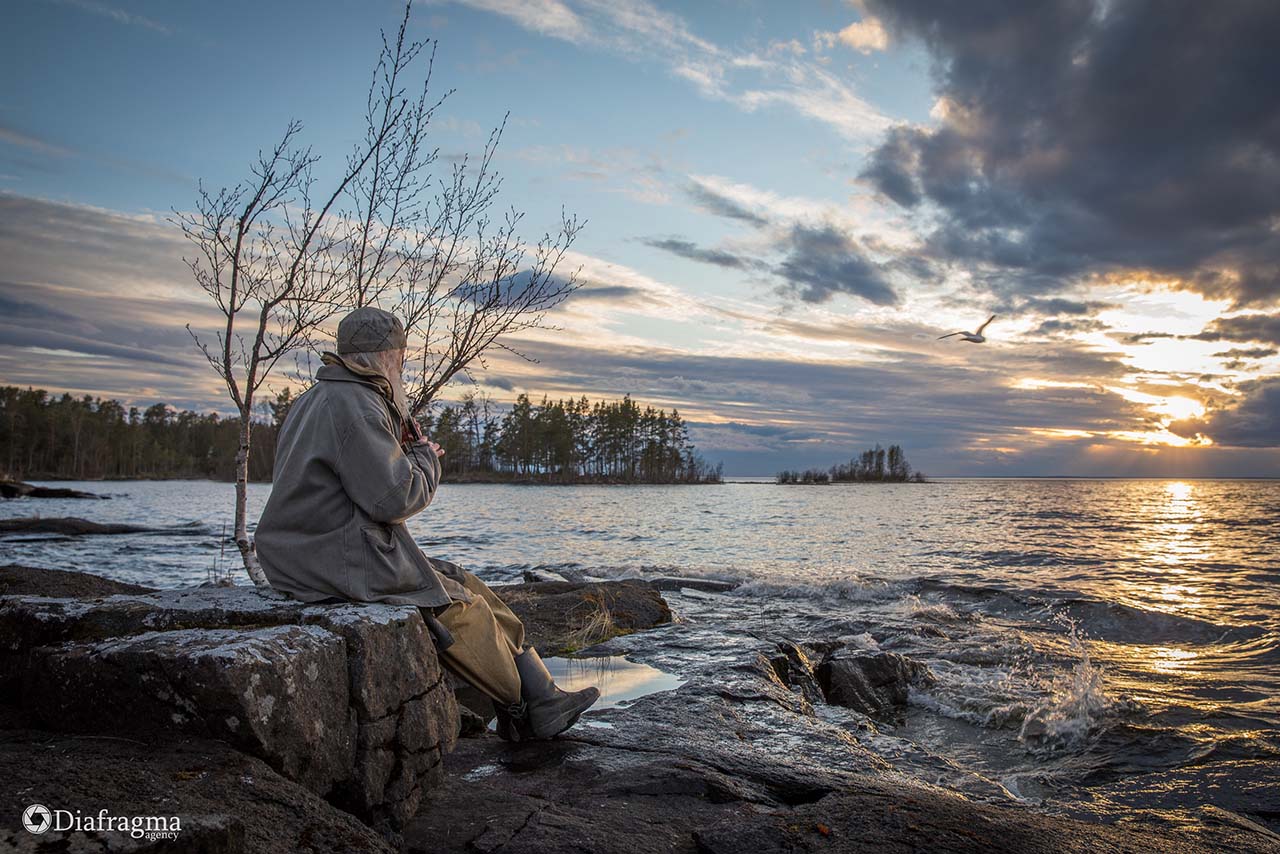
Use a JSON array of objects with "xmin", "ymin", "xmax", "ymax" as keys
[{"xmin": 436, "ymin": 572, "xmax": 525, "ymax": 705}]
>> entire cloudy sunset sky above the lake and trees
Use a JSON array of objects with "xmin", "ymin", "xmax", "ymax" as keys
[{"xmin": 0, "ymin": 0, "xmax": 1280, "ymax": 478}]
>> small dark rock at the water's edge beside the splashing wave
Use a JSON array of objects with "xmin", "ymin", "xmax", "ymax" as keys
[{"xmin": 817, "ymin": 649, "xmax": 933, "ymax": 720}]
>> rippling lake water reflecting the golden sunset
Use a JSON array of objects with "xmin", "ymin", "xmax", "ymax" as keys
[{"xmin": 0, "ymin": 479, "xmax": 1280, "ymax": 818}]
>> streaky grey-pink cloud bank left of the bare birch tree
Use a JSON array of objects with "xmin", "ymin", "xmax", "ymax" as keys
[{"xmin": 0, "ymin": 193, "xmax": 240, "ymax": 408}]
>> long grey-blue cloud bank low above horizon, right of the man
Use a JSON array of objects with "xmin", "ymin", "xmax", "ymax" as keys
[{"xmin": 476, "ymin": 333, "xmax": 1244, "ymax": 476}]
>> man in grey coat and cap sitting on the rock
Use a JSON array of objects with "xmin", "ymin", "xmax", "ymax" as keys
[{"xmin": 256, "ymin": 307, "xmax": 600, "ymax": 740}]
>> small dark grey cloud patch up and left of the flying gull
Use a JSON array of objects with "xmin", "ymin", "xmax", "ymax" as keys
[{"xmin": 774, "ymin": 225, "xmax": 899, "ymax": 306}]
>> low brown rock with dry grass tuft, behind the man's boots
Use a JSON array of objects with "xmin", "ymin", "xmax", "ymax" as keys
[{"xmin": 498, "ymin": 581, "xmax": 671, "ymax": 657}]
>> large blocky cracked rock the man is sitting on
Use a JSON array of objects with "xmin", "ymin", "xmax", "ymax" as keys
[{"xmin": 0, "ymin": 571, "xmax": 460, "ymax": 830}]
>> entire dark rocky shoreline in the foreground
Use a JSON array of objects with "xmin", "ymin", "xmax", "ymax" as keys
[{"xmin": 0, "ymin": 567, "xmax": 1280, "ymax": 854}]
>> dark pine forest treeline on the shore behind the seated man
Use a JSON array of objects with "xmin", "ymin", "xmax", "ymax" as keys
[{"xmin": 0, "ymin": 387, "xmax": 721, "ymax": 484}]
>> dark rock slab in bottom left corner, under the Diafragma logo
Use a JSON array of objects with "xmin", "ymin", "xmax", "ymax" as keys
[{"xmin": 0, "ymin": 730, "xmax": 396, "ymax": 854}]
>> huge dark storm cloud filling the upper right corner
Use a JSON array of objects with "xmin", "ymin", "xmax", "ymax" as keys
[{"xmin": 863, "ymin": 0, "xmax": 1280, "ymax": 305}]
